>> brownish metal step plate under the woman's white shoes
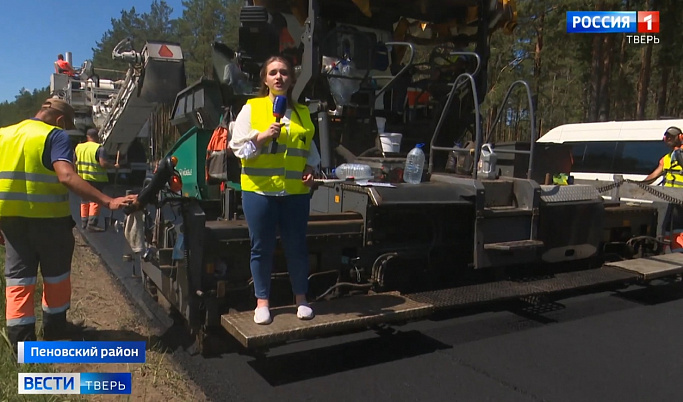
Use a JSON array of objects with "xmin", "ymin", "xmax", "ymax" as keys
[{"xmin": 221, "ymin": 292, "xmax": 433, "ymax": 348}]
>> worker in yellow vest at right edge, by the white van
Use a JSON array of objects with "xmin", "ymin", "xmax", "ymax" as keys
[{"xmin": 643, "ymin": 127, "xmax": 683, "ymax": 253}]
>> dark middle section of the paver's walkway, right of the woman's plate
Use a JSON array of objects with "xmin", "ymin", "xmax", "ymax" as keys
[{"xmin": 405, "ymin": 266, "xmax": 638, "ymax": 309}]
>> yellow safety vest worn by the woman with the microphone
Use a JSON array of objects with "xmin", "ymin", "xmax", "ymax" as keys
[{"xmin": 241, "ymin": 96, "xmax": 315, "ymax": 195}]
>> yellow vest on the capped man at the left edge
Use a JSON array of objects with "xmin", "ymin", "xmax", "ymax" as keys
[{"xmin": 0, "ymin": 120, "xmax": 71, "ymax": 218}]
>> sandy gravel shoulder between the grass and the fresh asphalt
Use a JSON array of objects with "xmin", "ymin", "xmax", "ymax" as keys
[{"xmin": 54, "ymin": 229, "xmax": 208, "ymax": 401}]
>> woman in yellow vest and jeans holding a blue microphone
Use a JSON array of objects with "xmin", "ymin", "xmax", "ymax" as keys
[{"xmin": 229, "ymin": 56, "xmax": 320, "ymax": 325}]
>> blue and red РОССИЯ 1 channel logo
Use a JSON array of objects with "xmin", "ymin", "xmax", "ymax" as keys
[{"xmin": 567, "ymin": 11, "xmax": 659, "ymax": 34}]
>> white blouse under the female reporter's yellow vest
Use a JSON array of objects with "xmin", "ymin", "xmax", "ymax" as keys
[{"xmin": 229, "ymin": 104, "xmax": 320, "ymax": 170}]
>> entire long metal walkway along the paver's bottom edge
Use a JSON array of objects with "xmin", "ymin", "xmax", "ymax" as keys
[{"xmin": 221, "ymin": 253, "xmax": 683, "ymax": 348}]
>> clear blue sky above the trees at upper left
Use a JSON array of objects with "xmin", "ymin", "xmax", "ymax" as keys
[{"xmin": 0, "ymin": 0, "xmax": 183, "ymax": 103}]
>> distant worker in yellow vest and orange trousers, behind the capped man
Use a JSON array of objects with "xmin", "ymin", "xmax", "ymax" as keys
[{"xmin": 76, "ymin": 128, "xmax": 119, "ymax": 232}]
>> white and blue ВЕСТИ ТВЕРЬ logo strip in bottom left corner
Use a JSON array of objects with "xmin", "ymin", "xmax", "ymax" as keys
[{"xmin": 18, "ymin": 373, "xmax": 133, "ymax": 395}]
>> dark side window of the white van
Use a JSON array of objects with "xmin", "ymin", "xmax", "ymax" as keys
[{"xmin": 571, "ymin": 141, "xmax": 671, "ymax": 175}]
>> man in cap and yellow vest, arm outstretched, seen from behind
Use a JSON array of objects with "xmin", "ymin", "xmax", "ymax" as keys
[{"xmin": 0, "ymin": 98, "xmax": 136, "ymax": 350}]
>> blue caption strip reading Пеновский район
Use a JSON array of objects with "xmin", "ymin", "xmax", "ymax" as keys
[{"xmin": 17, "ymin": 341, "xmax": 146, "ymax": 363}]
